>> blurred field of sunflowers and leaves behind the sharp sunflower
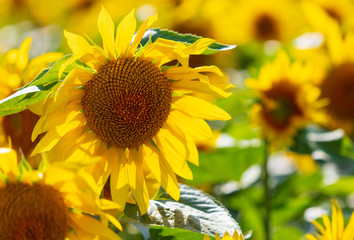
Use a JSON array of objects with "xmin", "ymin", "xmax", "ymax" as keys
[{"xmin": 0, "ymin": 0, "xmax": 354, "ymax": 240}]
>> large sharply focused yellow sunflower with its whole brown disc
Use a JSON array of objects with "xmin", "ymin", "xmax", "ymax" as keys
[{"xmin": 32, "ymin": 8, "xmax": 230, "ymax": 213}]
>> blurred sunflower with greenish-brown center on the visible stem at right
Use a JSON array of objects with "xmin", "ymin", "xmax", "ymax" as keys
[{"xmin": 246, "ymin": 51, "xmax": 325, "ymax": 147}]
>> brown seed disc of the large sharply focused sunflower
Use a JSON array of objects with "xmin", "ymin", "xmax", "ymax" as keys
[{"xmin": 82, "ymin": 58, "xmax": 172, "ymax": 148}]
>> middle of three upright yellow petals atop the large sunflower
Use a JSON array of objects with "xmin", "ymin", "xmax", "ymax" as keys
[{"xmin": 115, "ymin": 10, "xmax": 136, "ymax": 57}]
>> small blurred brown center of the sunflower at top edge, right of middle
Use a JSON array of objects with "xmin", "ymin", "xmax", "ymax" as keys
[{"xmin": 254, "ymin": 13, "xmax": 279, "ymax": 41}]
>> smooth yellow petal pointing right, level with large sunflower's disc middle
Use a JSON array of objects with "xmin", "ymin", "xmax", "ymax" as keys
[{"xmin": 173, "ymin": 95, "xmax": 231, "ymax": 120}]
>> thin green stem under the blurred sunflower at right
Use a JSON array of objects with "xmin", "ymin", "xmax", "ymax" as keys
[{"xmin": 262, "ymin": 139, "xmax": 271, "ymax": 240}]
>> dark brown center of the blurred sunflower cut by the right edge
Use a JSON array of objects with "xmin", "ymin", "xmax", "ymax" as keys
[{"xmin": 321, "ymin": 63, "xmax": 354, "ymax": 120}]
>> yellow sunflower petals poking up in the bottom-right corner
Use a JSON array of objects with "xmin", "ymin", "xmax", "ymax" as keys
[{"xmin": 306, "ymin": 200, "xmax": 354, "ymax": 240}]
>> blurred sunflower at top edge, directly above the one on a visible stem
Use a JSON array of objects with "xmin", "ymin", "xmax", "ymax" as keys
[{"xmin": 222, "ymin": 0, "xmax": 303, "ymax": 44}]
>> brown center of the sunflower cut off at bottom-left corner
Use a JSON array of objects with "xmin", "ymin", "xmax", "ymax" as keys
[{"xmin": 0, "ymin": 182, "xmax": 69, "ymax": 240}]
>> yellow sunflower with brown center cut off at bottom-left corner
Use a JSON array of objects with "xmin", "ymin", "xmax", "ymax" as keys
[{"xmin": 0, "ymin": 148, "xmax": 121, "ymax": 240}]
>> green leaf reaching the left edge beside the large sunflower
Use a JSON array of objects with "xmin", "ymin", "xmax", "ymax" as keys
[{"xmin": 0, "ymin": 55, "xmax": 85, "ymax": 116}]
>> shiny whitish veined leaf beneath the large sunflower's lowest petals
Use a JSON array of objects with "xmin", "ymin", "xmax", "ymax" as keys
[{"xmin": 125, "ymin": 184, "xmax": 241, "ymax": 236}]
